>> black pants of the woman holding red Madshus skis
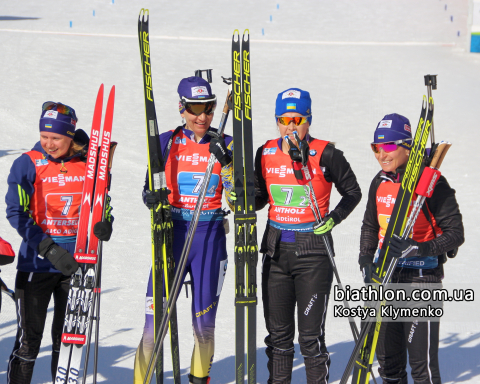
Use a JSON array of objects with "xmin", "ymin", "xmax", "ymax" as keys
[{"xmin": 7, "ymin": 271, "xmax": 70, "ymax": 384}]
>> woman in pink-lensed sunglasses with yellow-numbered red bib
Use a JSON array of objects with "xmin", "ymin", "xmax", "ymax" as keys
[{"xmin": 359, "ymin": 114, "xmax": 464, "ymax": 384}]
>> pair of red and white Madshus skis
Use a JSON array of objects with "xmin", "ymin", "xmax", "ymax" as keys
[{"xmin": 55, "ymin": 84, "xmax": 115, "ymax": 383}]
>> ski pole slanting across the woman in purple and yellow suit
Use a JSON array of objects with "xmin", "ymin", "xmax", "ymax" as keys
[{"xmin": 143, "ymin": 79, "xmax": 231, "ymax": 384}]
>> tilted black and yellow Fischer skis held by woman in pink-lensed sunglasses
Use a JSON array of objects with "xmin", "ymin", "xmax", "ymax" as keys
[{"xmin": 340, "ymin": 97, "xmax": 433, "ymax": 384}]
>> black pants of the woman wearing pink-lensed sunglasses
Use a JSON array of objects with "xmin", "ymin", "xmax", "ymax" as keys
[{"xmin": 377, "ymin": 268, "xmax": 442, "ymax": 384}]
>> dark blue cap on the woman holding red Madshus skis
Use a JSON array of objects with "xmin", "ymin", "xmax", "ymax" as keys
[{"xmin": 39, "ymin": 101, "xmax": 78, "ymax": 139}]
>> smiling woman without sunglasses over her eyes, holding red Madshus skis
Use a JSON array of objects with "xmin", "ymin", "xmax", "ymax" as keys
[{"xmin": 5, "ymin": 101, "xmax": 111, "ymax": 384}]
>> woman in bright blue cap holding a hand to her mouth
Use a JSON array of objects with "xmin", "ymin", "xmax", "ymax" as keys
[{"xmin": 255, "ymin": 88, "xmax": 362, "ymax": 384}]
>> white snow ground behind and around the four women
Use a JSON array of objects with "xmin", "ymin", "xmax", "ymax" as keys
[{"xmin": 0, "ymin": 0, "xmax": 480, "ymax": 383}]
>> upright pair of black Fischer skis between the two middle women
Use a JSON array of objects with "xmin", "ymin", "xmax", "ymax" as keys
[{"xmin": 232, "ymin": 29, "xmax": 258, "ymax": 384}]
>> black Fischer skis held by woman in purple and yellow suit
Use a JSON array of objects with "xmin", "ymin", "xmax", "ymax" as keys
[{"xmin": 138, "ymin": 8, "xmax": 181, "ymax": 384}]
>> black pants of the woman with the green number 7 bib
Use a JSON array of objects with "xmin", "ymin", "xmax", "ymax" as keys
[{"xmin": 262, "ymin": 243, "xmax": 333, "ymax": 384}]
